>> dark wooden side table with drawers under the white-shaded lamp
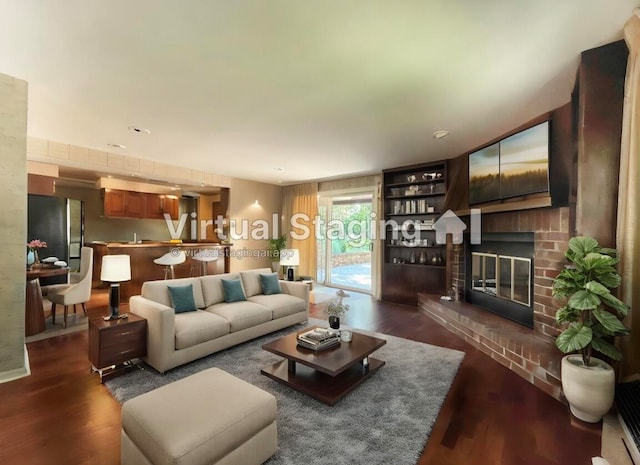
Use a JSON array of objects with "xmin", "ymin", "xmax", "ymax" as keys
[{"xmin": 89, "ymin": 313, "xmax": 147, "ymax": 382}]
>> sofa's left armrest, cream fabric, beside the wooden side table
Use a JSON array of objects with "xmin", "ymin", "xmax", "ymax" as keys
[{"xmin": 129, "ymin": 295, "xmax": 176, "ymax": 373}]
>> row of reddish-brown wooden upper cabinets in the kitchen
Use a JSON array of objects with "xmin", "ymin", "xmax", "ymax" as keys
[{"xmin": 103, "ymin": 189, "xmax": 180, "ymax": 220}]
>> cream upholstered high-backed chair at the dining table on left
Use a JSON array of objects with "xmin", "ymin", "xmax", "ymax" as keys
[{"xmin": 47, "ymin": 247, "xmax": 93, "ymax": 328}]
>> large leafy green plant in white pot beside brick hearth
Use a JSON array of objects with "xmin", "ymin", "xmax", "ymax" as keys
[{"xmin": 553, "ymin": 236, "xmax": 629, "ymax": 423}]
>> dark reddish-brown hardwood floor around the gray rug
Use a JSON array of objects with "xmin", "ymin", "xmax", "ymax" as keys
[{"xmin": 0, "ymin": 291, "xmax": 601, "ymax": 465}]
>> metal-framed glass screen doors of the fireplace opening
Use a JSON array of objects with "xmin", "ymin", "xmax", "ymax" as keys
[{"xmin": 471, "ymin": 252, "xmax": 531, "ymax": 306}]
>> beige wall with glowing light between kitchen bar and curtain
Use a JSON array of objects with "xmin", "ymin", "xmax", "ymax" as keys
[{"xmin": 229, "ymin": 178, "xmax": 282, "ymax": 272}]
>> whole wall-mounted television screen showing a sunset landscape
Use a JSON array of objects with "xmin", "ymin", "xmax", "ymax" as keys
[{"xmin": 469, "ymin": 121, "xmax": 549, "ymax": 205}]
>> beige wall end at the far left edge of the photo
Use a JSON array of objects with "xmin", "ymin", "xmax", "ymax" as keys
[{"xmin": 0, "ymin": 74, "xmax": 29, "ymax": 382}]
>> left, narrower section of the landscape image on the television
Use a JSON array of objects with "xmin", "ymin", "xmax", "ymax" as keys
[{"xmin": 469, "ymin": 144, "xmax": 500, "ymax": 204}]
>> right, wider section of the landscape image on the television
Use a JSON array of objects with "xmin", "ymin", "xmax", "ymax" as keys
[{"xmin": 500, "ymin": 121, "xmax": 549, "ymax": 199}]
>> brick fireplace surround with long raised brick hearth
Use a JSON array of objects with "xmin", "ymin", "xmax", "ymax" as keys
[{"xmin": 419, "ymin": 207, "xmax": 573, "ymax": 399}]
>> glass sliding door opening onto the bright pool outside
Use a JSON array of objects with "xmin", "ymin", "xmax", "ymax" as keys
[{"xmin": 316, "ymin": 188, "xmax": 377, "ymax": 294}]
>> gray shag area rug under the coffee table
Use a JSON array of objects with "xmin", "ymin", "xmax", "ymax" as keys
[{"xmin": 105, "ymin": 319, "xmax": 464, "ymax": 465}]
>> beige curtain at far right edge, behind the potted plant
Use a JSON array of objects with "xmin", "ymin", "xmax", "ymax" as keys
[{"xmin": 616, "ymin": 9, "xmax": 640, "ymax": 377}]
